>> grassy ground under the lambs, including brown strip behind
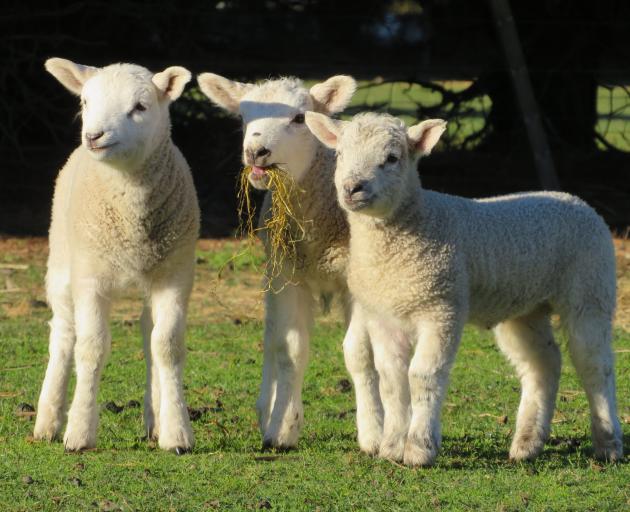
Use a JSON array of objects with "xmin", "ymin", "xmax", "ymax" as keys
[{"xmin": 0, "ymin": 239, "xmax": 630, "ymax": 511}]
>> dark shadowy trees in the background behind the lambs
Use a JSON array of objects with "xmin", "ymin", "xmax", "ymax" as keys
[{"xmin": 0, "ymin": 0, "xmax": 630, "ymax": 236}]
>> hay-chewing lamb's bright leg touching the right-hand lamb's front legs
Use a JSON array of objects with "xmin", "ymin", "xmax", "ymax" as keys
[{"xmin": 343, "ymin": 304, "xmax": 383, "ymax": 455}]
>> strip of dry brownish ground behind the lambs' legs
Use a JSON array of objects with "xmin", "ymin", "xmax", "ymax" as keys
[{"xmin": 0, "ymin": 234, "xmax": 630, "ymax": 331}]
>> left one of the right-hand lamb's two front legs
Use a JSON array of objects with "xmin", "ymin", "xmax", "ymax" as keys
[{"xmin": 368, "ymin": 320, "xmax": 411, "ymax": 461}]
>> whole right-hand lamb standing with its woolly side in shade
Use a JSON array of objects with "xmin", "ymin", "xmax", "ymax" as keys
[{"xmin": 306, "ymin": 112, "xmax": 623, "ymax": 466}]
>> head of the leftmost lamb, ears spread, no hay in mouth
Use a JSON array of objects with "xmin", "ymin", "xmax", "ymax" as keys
[{"xmin": 46, "ymin": 58, "xmax": 191, "ymax": 169}]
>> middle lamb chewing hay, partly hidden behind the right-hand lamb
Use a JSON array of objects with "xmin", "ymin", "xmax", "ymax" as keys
[{"xmin": 197, "ymin": 73, "xmax": 382, "ymax": 453}]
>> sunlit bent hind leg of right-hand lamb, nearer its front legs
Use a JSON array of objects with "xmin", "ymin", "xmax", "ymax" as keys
[{"xmin": 495, "ymin": 311, "xmax": 561, "ymax": 460}]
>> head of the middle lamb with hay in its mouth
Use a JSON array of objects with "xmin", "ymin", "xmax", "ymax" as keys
[{"xmin": 197, "ymin": 73, "xmax": 356, "ymax": 190}]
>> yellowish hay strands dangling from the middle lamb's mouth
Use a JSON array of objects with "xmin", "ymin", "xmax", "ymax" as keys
[{"xmin": 237, "ymin": 166, "xmax": 306, "ymax": 293}]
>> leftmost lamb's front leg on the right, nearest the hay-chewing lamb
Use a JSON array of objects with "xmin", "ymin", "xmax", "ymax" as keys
[{"xmin": 147, "ymin": 269, "xmax": 194, "ymax": 454}]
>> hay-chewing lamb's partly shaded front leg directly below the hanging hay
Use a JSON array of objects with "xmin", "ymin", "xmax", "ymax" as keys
[{"xmin": 258, "ymin": 285, "xmax": 313, "ymax": 448}]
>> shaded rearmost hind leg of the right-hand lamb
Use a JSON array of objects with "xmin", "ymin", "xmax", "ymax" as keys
[{"xmin": 567, "ymin": 312, "xmax": 623, "ymax": 461}]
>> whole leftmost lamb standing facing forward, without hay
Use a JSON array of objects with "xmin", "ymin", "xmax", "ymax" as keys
[{"xmin": 34, "ymin": 58, "xmax": 199, "ymax": 454}]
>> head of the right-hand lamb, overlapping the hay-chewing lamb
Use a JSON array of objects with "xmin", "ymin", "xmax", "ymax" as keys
[{"xmin": 306, "ymin": 112, "xmax": 446, "ymax": 218}]
